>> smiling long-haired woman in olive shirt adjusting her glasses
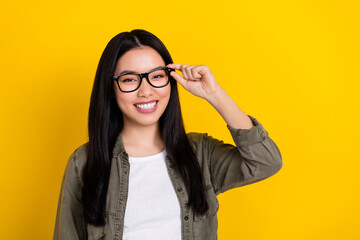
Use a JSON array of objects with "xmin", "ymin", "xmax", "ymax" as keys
[{"xmin": 54, "ymin": 29, "xmax": 282, "ymax": 240}]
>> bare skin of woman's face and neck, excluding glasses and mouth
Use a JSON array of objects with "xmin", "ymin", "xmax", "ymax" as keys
[{"xmin": 114, "ymin": 46, "xmax": 171, "ymax": 157}]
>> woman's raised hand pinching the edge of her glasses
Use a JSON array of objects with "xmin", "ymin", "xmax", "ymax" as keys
[{"xmin": 167, "ymin": 63, "xmax": 221, "ymax": 101}]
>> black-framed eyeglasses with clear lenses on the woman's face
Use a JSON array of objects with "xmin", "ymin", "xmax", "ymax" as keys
[{"xmin": 113, "ymin": 67, "xmax": 175, "ymax": 93}]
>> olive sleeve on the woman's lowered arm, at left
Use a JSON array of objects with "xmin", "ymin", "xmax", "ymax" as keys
[{"xmin": 53, "ymin": 151, "xmax": 86, "ymax": 240}]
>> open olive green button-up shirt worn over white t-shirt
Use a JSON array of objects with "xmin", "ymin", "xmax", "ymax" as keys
[{"xmin": 53, "ymin": 115, "xmax": 282, "ymax": 240}]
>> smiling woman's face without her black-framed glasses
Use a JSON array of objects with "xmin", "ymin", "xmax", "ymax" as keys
[{"xmin": 114, "ymin": 46, "xmax": 171, "ymax": 127}]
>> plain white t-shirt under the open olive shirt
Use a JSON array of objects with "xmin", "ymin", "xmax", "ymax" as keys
[{"xmin": 123, "ymin": 150, "xmax": 181, "ymax": 240}]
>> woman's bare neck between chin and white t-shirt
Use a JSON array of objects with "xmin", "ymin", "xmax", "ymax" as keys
[{"xmin": 121, "ymin": 122, "xmax": 165, "ymax": 157}]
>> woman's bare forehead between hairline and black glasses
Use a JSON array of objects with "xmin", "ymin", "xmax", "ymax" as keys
[{"xmin": 115, "ymin": 46, "xmax": 165, "ymax": 72}]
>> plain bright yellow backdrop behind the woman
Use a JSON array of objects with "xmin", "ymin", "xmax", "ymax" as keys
[{"xmin": 0, "ymin": 0, "xmax": 360, "ymax": 240}]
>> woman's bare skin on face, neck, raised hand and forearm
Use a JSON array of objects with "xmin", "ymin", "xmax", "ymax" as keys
[{"xmin": 114, "ymin": 46, "xmax": 253, "ymax": 157}]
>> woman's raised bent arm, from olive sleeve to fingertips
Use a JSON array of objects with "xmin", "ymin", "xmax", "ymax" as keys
[{"xmin": 168, "ymin": 64, "xmax": 282, "ymax": 194}]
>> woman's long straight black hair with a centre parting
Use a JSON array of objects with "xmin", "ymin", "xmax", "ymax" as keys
[{"xmin": 82, "ymin": 29, "xmax": 208, "ymax": 225}]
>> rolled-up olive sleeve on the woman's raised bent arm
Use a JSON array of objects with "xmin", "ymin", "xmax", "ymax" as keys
[{"xmin": 205, "ymin": 115, "xmax": 282, "ymax": 194}]
